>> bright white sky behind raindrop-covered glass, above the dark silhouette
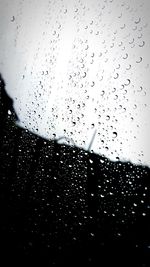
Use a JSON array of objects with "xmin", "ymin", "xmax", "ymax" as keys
[{"xmin": 0, "ymin": 0, "xmax": 150, "ymax": 166}]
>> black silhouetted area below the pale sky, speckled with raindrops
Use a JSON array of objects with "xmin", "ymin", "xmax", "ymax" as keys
[{"xmin": 0, "ymin": 73, "xmax": 150, "ymax": 267}]
